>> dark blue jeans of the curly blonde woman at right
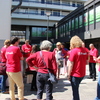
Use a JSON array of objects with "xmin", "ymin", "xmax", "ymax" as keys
[{"xmin": 71, "ymin": 76, "xmax": 84, "ymax": 100}]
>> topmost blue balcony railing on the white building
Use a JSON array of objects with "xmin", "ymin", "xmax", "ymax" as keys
[{"xmin": 12, "ymin": 0, "xmax": 82, "ymax": 7}]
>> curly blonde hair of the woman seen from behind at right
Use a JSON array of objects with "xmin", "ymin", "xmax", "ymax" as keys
[{"xmin": 70, "ymin": 35, "xmax": 83, "ymax": 48}]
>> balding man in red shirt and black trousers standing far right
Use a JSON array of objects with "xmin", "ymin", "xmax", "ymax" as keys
[{"xmin": 89, "ymin": 44, "xmax": 98, "ymax": 81}]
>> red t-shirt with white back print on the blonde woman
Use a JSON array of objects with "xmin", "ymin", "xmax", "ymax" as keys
[{"xmin": 69, "ymin": 47, "xmax": 88, "ymax": 77}]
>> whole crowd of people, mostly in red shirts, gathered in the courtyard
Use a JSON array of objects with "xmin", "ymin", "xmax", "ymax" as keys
[{"xmin": 1, "ymin": 36, "xmax": 100, "ymax": 100}]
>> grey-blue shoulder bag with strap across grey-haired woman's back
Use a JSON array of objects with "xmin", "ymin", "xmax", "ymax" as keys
[{"xmin": 40, "ymin": 51, "xmax": 58, "ymax": 84}]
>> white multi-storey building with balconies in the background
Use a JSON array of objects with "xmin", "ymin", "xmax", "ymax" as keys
[{"xmin": 11, "ymin": 0, "xmax": 87, "ymax": 44}]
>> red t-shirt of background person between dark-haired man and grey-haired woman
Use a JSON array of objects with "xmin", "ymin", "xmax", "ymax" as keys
[{"xmin": 22, "ymin": 44, "xmax": 32, "ymax": 58}]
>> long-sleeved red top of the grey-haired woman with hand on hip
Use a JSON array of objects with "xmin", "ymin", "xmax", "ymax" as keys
[{"xmin": 26, "ymin": 51, "xmax": 57, "ymax": 75}]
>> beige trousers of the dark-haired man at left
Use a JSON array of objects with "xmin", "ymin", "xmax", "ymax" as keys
[{"xmin": 7, "ymin": 72, "xmax": 24, "ymax": 100}]
